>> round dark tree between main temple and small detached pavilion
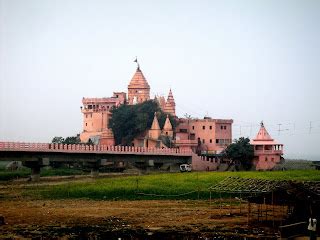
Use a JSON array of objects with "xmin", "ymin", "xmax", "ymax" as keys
[{"xmin": 224, "ymin": 137, "xmax": 254, "ymax": 170}]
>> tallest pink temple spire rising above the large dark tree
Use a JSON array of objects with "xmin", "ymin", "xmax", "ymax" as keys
[{"xmin": 128, "ymin": 64, "xmax": 150, "ymax": 105}]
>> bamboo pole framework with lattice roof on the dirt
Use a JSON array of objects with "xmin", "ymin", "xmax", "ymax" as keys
[{"xmin": 209, "ymin": 177, "xmax": 320, "ymax": 229}]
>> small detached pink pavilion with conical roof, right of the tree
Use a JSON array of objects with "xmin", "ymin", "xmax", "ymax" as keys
[{"xmin": 251, "ymin": 122, "xmax": 283, "ymax": 170}]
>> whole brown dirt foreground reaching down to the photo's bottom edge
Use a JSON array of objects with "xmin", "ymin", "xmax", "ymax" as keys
[{"xmin": 0, "ymin": 179, "xmax": 277, "ymax": 240}]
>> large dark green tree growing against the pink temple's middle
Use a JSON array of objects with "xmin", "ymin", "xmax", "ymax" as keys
[{"xmin": 108, "ymin": 100, "xmax": 176, "ymax": 145}]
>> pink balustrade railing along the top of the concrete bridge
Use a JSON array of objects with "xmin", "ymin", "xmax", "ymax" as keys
[{"xmin": 0, "ymin": 142, "xmax": 192, "ymax": 156}]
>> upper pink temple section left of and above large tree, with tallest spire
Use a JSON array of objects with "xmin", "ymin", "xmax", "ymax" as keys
[{"xmin": 80, "ymin": 64, "xmax": 176, "ymax": 146}]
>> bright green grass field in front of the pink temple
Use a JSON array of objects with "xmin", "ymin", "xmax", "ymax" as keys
[{"xmin": 24, "ymin": 170, "xmax": 320, "ymax": 200}]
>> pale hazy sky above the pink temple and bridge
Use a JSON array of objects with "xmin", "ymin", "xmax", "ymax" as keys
[{"xmin": 0, "ymin": 0, "xmax": 320, "ymax": 160}]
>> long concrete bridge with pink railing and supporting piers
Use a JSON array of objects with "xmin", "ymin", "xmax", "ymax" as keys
[{"xmin": 0, "ymin": 142, "xmax": 195, "ymax": 181}]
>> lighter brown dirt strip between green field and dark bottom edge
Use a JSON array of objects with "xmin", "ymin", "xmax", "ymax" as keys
[{"xmin": 0, "ymin": 200, "xmax": 280, "ymax": 239}]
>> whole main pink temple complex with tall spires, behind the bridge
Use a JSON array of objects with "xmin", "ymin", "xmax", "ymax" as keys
[{"xmin": 80, "ymin": 61, "xmax": 233, "ymax": 170}]
